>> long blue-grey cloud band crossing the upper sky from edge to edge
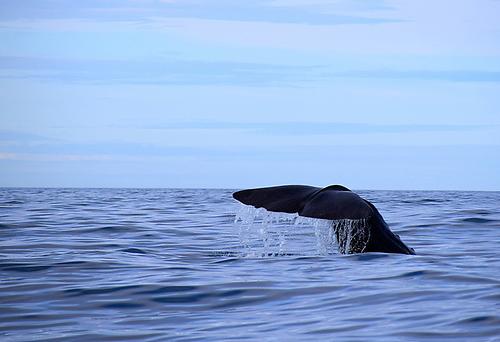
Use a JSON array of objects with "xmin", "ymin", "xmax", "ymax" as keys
[{"xmin": 0, "ymin": 57, "xmax": 500, "ymax": 86}]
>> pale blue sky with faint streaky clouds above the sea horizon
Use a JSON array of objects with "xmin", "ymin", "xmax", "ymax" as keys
[{"xmin": 0, "ymin": 0, "xmax": 500, "ymax": 190}]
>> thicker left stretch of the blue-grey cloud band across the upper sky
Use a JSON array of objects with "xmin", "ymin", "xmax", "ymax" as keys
[{"xmin": 0, "ymin": 57, "xmax": 319, "ymax": 86}]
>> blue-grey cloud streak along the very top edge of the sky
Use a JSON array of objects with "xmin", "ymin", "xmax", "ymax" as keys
[{"xmin": 0, "ymin": 0, "xmax": 395, "ymax": 25}]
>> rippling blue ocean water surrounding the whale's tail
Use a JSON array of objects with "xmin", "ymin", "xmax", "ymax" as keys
[{"xmin": 0, "ymin": 189, "xmax": 500, "ymax": 341}]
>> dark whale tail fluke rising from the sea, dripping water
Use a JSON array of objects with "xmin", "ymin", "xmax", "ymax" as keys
[{"xmin": 233, "ymin": 185, "xmax": 415, "ymax": 255}]
